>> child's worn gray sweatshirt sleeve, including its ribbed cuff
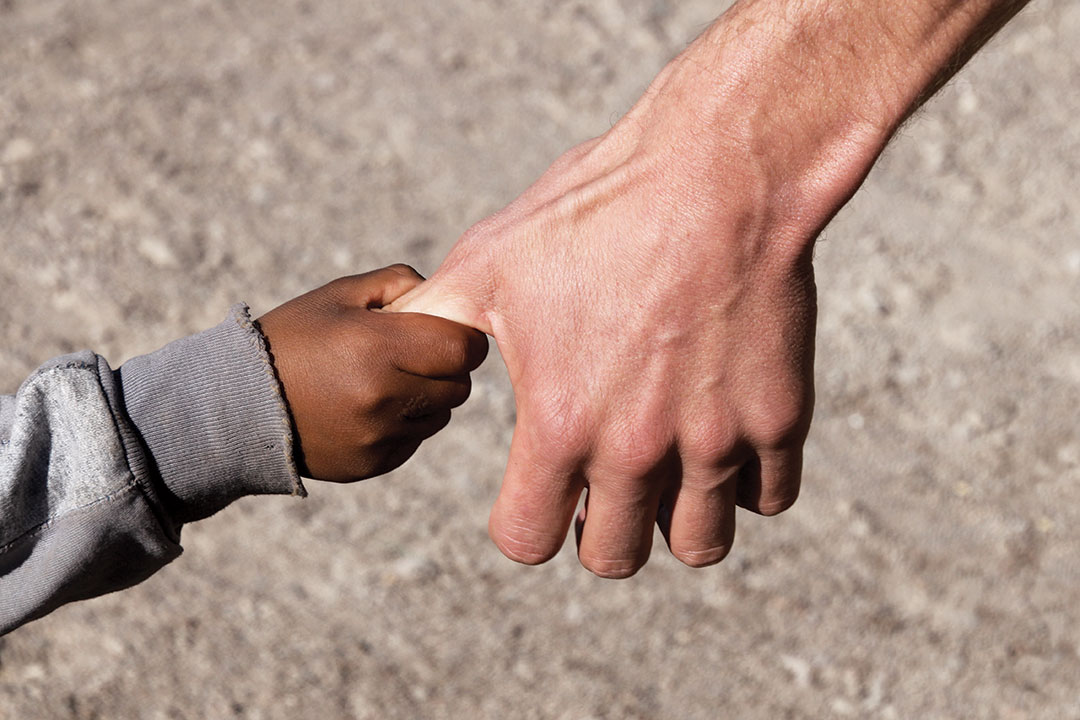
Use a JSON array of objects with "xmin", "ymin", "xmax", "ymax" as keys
[{"xmin": 0, "ymin": 305, "xmax": 305, "ymax": 634}]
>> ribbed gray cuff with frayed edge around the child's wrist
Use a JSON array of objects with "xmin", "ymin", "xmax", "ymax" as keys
[{"xmin": 118, "ymin": 304, "xmax": 307, "ymax": 522}]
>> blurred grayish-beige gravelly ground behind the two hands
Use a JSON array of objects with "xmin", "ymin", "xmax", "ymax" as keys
[{"xmin": 0, "ymin": 0, "xmax": 1080, "ymax": 720}]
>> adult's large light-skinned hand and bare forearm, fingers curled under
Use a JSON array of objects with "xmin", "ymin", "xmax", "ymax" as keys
[{"xmin": 391, "ymin": 0, "xmax": 1026, "ymax": 578}]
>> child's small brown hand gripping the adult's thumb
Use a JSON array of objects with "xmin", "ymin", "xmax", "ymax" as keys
[{"xmin": 252, "ymin": 264, "xmax": 487, "ymax": 483}]
